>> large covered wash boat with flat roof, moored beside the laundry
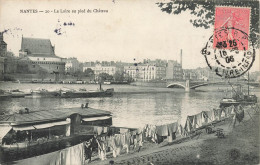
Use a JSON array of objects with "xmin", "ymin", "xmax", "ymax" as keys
[{"xmin": 0, "ymin": 104, "xmax": 112, "ymax": 164}]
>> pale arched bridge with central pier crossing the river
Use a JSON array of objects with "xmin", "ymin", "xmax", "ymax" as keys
[{"xmin": 166, "ymin": 80, "xmax": 226, "ymax": 92}]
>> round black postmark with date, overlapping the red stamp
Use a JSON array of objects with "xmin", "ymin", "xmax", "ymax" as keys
[{"xmin": 201, "ymin": 28, "xmax": 255, "ymax": 78}]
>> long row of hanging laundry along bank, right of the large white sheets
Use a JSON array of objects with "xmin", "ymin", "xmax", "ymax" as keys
[{"xmin": 84, "ymin": 106, "xmax": 247, "ymax": 160}]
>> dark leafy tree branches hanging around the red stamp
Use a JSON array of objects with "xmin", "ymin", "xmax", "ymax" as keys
[{"xmin": 156, "ymin": 0, "xmax": 259, "ymax": 48}]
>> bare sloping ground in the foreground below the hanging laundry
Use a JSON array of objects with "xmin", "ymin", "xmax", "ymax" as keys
[{"xmin": 90, "ymin": 105, "xmax": 259, "ymax": 165}]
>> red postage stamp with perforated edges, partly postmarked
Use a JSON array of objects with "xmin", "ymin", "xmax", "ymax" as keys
[{"xmin": 213, "ymin": 7, "xmax": 250, "ymax": 50}]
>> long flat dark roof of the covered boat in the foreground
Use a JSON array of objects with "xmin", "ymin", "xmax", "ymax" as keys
[{"xmin": 0, "ymin": 108, "xmax": 111, "ymax": 125}]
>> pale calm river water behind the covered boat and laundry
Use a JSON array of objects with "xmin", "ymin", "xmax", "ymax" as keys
[{"xmin": 0, "ymin": 83, "xmax": 258, "ymax": 128}]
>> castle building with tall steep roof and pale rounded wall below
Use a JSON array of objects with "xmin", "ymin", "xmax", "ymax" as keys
[{"xmin": 19, "ymin": 37, "xmax": 65, "ymax": 73}]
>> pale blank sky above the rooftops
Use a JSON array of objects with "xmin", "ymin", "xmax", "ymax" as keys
[{"xmin": 0, "ymin": 0, "xmax": 259, "ymax": 69}]
